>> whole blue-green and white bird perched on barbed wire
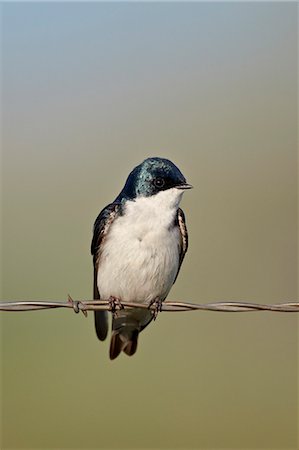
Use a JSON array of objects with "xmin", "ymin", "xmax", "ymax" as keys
[{"xmin": 91, "ymin": 157, "xmax": 192, "ymax": 360}]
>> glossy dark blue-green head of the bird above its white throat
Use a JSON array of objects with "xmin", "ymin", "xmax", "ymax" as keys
[{"xmin": 119, "ymin": 157, "xmax": 192, "ymax": 200}]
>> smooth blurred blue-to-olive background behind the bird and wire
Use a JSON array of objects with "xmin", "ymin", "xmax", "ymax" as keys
[{"xmin": 1, "ymin": 3, "xmax": 298, "ymax": 449}]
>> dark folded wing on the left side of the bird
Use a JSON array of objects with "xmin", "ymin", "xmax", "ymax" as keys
[{"xmin": 91, "ymin": 203, "xmax": 120, "ymax": 341}]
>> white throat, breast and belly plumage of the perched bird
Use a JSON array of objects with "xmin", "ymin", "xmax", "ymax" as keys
[{"xmin": 97, "ymin": 188, "xmax": 182, "ymax": 302}]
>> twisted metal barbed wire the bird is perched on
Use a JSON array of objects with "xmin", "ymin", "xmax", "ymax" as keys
[{"xmin": 0, "ymin": 296, "xmax": 299, "ymax": 316}]
